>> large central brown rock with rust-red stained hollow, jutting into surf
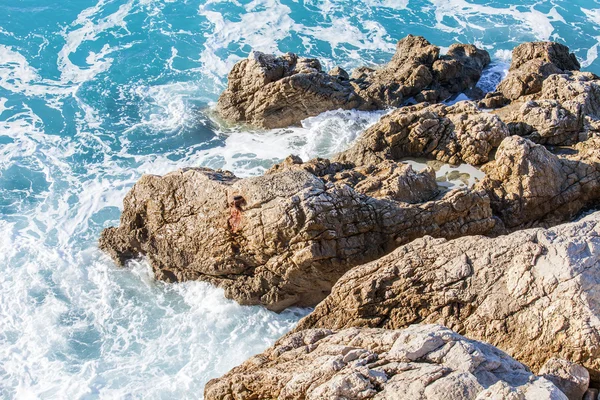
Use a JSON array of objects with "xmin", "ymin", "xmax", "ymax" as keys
[{"xmin": 100, "ymin": 164, "xmax": 494, "ymax": 311}]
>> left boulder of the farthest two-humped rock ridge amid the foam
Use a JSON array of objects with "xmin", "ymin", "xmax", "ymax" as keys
[{"xmin": 217, "ymin": 51, "xmax": 362, "ymax": 128}]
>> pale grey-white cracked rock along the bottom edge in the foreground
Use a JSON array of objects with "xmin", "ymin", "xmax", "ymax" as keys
[{"xmin": 204, "ymin": 325, "xmax": 567, "ymax": 400}]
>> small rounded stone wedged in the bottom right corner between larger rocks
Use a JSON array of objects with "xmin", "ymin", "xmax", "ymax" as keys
[{"xmin": 540, "ymin": 358, "xmax": 590, "ymax": 400}]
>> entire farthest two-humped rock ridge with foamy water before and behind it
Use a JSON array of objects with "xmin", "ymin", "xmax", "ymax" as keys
[{"xmin": 217, "ymin": 35, "xmax": 490, "ymax": 128}]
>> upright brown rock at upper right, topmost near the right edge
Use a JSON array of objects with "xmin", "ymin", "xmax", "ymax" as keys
[{"xmin": 497, "ymin": 42, "xmax": 580, "ymax": 100}]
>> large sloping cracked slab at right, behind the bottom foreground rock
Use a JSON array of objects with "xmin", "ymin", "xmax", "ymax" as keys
[{"xmin": 296, "ymin": 212, "xmax": 600, "ymax": 382}]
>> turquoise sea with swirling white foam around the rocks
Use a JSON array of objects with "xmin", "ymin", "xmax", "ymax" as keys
[{"xmin": 0, "ymin": 0, "xmax": 600, "ymax": 399}]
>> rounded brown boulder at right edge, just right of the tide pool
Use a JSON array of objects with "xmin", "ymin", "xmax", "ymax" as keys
[{"xmin": 476, "ymin": 136, "xmax": 600, "ymax": 230}]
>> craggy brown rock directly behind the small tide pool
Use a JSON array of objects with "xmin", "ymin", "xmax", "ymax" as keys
[{"xmin": 334, "ymin": 102, "xmax": 509, "ymax": 165}]
